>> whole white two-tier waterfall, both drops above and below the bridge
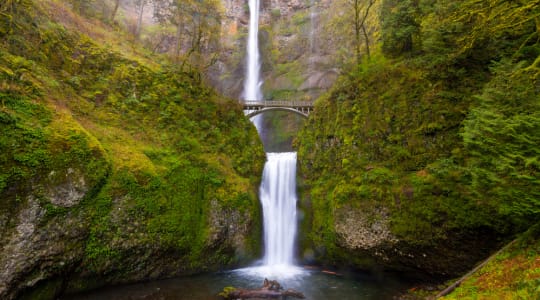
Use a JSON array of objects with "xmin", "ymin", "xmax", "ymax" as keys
[{"xmin": 242, "ymin": 0, "xmax": 302, "ymax": 278}]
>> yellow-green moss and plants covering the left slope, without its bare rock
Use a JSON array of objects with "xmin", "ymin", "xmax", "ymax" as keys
[{"xmin": 0, "ymin": 1, "xmax": 264, "ymax": 290}]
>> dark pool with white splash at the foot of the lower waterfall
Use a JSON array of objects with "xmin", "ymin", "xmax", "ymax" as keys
[{"xmin": 62, "ymin": 267, "xmax": 408, "ymax": 300}]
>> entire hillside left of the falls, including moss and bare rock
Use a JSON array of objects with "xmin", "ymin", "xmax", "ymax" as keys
[{"xmin": 0, "ymin": 0, "xmax": 264, "ymax": 299}]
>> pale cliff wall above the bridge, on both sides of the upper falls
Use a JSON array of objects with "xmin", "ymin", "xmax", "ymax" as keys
[{"xmin": 210, "ymin": 0, "xmax": 341, "ymax": 100}]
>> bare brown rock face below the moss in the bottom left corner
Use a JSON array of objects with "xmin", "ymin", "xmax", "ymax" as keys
[{"xmin": 0, "ymin": 196, "xmax": 88, "ymax": 299}]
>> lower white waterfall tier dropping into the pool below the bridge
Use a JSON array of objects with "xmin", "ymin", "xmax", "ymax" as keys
[{"xmin": 259, "ymin": 152, "xmax": 296, "ymax": 266}]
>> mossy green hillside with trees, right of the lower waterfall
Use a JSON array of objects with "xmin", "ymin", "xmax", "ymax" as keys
[{"xmin": 297, "ymin": 0, "xmax": 540, "ymax": 286}]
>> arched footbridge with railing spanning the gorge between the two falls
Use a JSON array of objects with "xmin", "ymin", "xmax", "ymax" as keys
[{"xmin": 243, "ymin": 100, "xmax": 314, "ymax": 118}]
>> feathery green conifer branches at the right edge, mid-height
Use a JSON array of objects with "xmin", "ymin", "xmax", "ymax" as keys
[{"xmin": 463, "ymin": 60, "xmax": 540, "ymax": 218}]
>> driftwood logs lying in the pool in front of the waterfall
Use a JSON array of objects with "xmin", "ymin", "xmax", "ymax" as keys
[{"xmin": 220, "ymin": 279, "xmax": 305, "ymax": 299}]
